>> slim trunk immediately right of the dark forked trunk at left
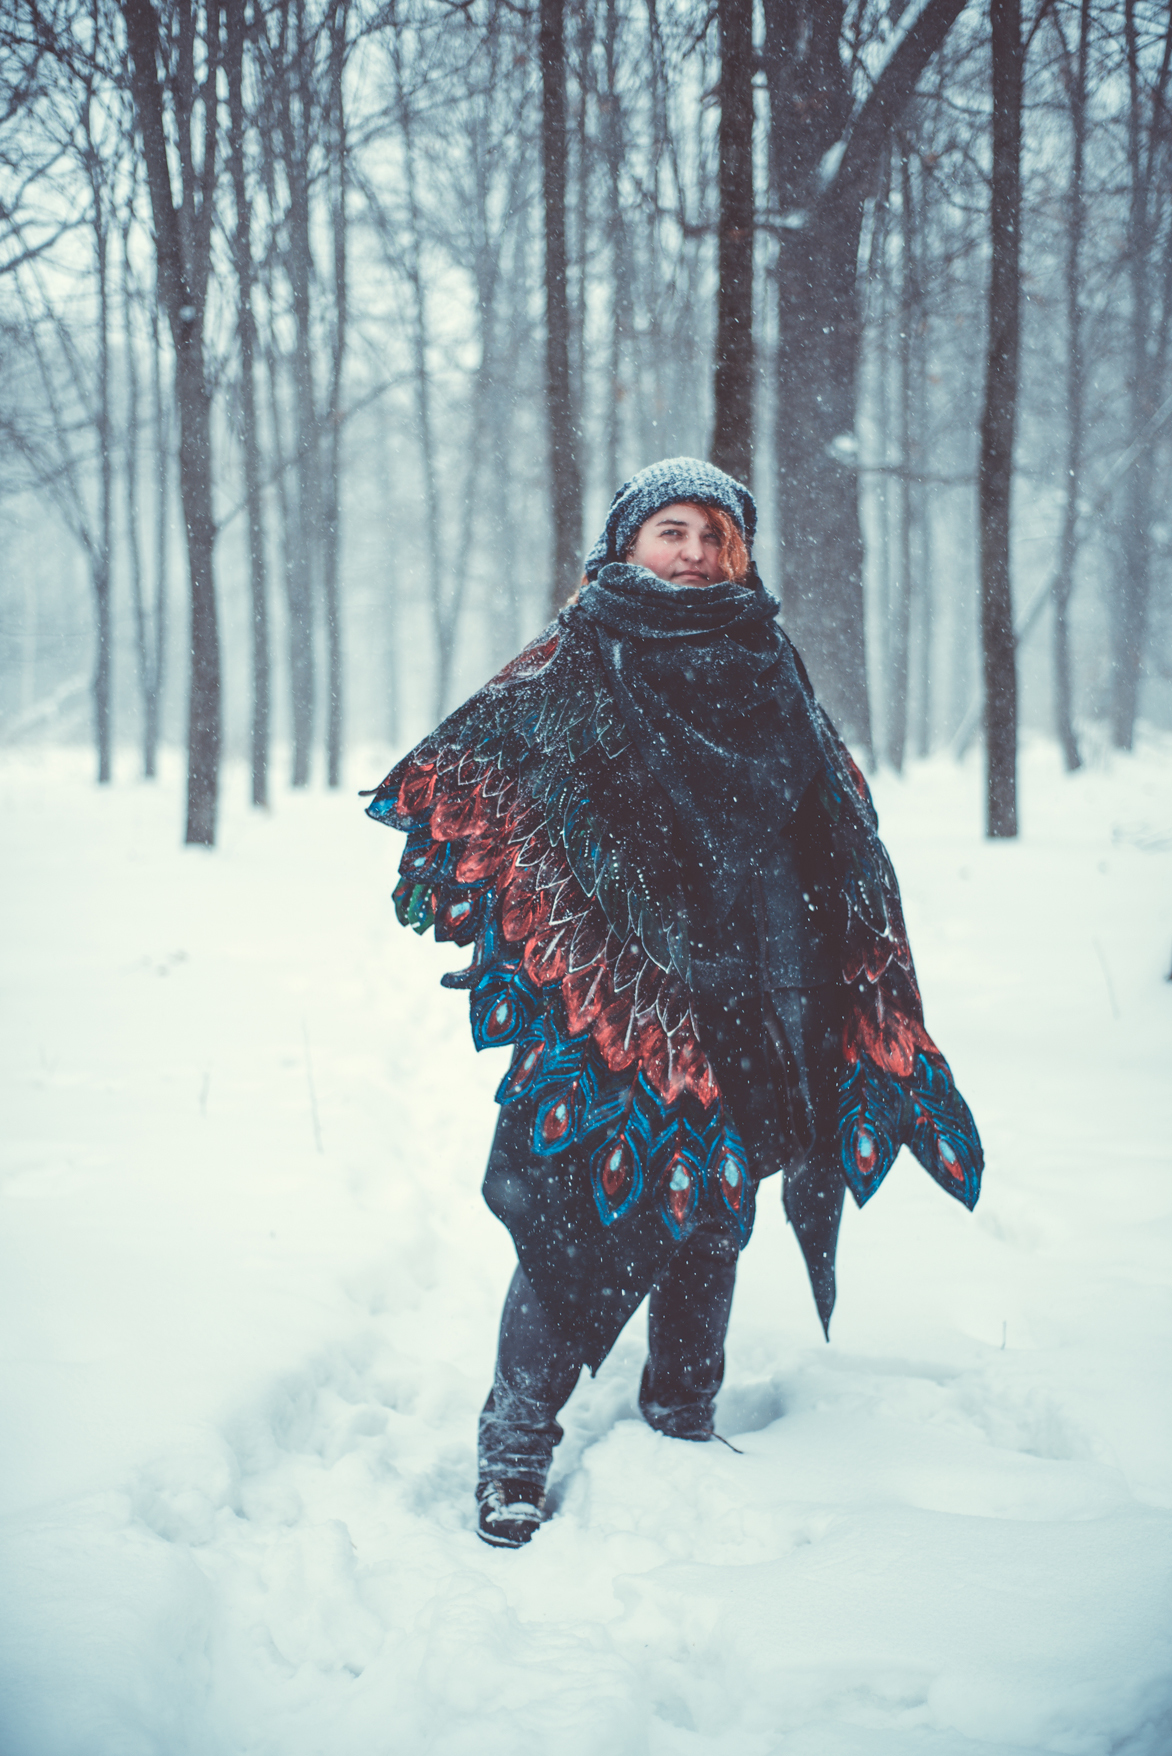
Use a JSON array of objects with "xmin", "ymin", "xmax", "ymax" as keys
[{"xmin": 225, "ymin": 0, "xmax": 271, "ymax": 806}]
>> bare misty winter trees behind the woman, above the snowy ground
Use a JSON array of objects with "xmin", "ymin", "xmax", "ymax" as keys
[{"xmin": 0, "ymin": 0, "xmax": 1172, "ymax": 841}]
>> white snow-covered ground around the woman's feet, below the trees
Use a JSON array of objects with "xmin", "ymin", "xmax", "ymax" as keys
[{"xmin": 0, "ymin": 741, "xmax": 1172, "ymax": 1756}]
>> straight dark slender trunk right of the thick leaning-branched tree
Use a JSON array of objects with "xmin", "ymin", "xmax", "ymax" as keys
[{"xmin": 979, "ymin": 0, "xmax": 1024, "ymax": 836}]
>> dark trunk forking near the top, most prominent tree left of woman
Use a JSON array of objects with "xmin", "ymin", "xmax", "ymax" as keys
[{"xmin": 121, "ymin": 0, "xmax": 221, "ymax": 846}]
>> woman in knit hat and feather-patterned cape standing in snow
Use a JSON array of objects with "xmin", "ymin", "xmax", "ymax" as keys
[{"xmin": 369, "ymin": 458, "xmax": 982, "ymax": 1547}]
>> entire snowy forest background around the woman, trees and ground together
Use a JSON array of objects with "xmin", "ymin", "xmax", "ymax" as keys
[{"xmin": 0, "ymin": 0, "xmax": 1172, "ymax": 1756}]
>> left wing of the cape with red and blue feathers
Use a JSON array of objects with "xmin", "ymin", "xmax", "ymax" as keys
[{"xmin": 369, "ymin": 613, "xmax": 752, "ymax": 1240}]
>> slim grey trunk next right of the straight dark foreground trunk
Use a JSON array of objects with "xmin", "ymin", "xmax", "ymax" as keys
[{"xmin": 1051, "ymin": 0, "xmax": 1091, "ymax": 774}]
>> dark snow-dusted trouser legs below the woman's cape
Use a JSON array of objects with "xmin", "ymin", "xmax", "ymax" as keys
[{"xmin": 480, "ymin": 1226, "xmax": 736, "ymax": 1482}]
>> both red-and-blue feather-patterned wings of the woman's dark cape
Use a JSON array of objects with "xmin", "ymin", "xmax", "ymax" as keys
[{"xmin": 367, "ymin": 609, "xmax": 982, "ymax": 1322}]
